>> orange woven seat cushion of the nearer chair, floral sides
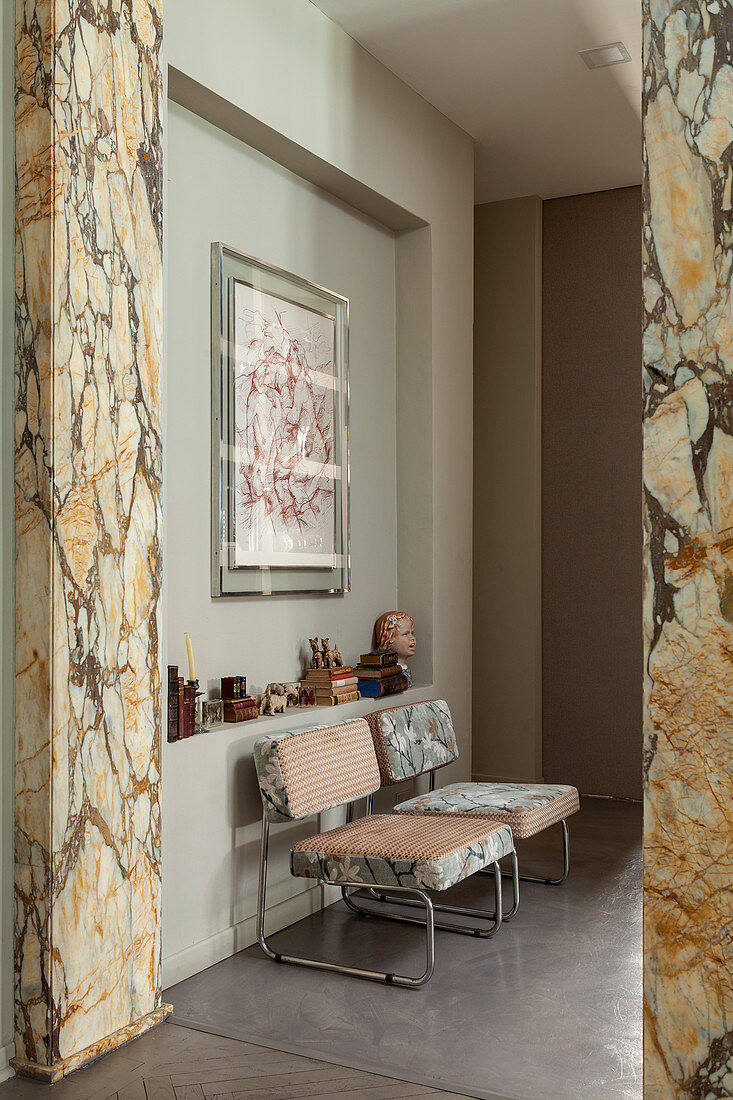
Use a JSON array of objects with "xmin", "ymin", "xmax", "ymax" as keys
[{"xmin": 291, "ymin": 814, "xmax": 514, "ymax": 890}]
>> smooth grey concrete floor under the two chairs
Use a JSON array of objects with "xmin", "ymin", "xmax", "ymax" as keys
[{"xmin": 165, "ymin": 799, "xmax": 642, "ymax": 1100}]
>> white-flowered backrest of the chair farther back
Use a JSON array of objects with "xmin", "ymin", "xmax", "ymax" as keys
[{"xmin": 367, "ymin": 699, "xmax": 458, "ymax": 787}]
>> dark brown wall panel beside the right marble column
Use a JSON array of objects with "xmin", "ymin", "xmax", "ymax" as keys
[{"xmin": 543, "ymin": 187, "xmax": 642, "ymax": 799}]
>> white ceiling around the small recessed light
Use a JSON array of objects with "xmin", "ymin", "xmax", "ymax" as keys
[{"xmin": 313, "ymin": 0, "xmax": 642, "ymax": 202}]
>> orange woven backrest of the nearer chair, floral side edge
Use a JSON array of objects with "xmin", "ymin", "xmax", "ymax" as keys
[{"xmin": 254, "ymin": 718, "xmax": 380, "ymax": 822}]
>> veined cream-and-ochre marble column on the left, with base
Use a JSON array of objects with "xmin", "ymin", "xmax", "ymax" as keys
[{"xmin": 14, "ymin": 0, "xmax": 166, "ymax": 1080}]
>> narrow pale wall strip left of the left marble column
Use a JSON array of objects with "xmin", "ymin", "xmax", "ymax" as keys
[{"xmin": 0, "ymin": 3, "xmax": 15, "ymax": 1081}]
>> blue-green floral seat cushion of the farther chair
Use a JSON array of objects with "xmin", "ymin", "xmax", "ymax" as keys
[{"xmin": 394, "ymin": 783, "xmax": 580, "ymax": 839}]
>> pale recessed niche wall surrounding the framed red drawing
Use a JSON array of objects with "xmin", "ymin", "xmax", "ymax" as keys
[{"xmin": 166, "ymin": 103, "xmax": 397, "ymax": 691}]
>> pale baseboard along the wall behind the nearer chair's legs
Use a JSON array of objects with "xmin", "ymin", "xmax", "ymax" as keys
[{"xmin": 162, "ymin": 887, "xmax": 339, "ymax": 989}]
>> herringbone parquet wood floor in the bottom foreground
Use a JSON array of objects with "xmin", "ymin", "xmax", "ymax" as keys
[{"xmin": 0, "ymin": 1023, "xmax": 459, "ymax": 1100}]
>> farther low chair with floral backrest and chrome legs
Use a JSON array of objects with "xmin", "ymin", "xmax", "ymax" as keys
[{"xmin": 367, "ymin": 700, "xmax": 580, "ymax": 893}]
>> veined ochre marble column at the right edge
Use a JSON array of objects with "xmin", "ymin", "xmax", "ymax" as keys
[{"xmin": 644, "ymin": 0, "xmax": 733, "ymax": 1100}]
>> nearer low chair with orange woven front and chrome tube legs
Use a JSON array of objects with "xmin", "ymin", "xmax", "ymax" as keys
[{"xmin": 254, "ymin": 718, "xmax": 514, "ymax": 987}]
